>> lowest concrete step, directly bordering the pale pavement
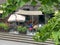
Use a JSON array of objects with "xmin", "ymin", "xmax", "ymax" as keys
[{"xmin": 0, "ymin": 37, "xmax": 53, "ymax": 45}]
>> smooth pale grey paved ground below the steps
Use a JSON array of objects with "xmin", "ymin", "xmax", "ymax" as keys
[{"xmin": 0, "ymin": 40, "xmax": 54, "ymax": 45}]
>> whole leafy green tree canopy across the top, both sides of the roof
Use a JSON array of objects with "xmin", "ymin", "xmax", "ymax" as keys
[{"xmin": 2, "ymin": 0, "xmax": 60, "ymax": 18}]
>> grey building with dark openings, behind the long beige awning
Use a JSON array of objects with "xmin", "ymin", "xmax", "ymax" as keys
[{"xmin": 0, "ymin": 0, "xmax": 54, "ymax": 24}]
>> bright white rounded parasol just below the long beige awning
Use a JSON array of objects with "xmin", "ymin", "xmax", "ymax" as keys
[{"xmin": 8, "ymin": 14, "xmax": 25, "ymax": 22}]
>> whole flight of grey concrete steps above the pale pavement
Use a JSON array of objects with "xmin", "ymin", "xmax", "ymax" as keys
[{"xmin": 0, "ymin": 33, "xmax": 54, "ymax": 45}]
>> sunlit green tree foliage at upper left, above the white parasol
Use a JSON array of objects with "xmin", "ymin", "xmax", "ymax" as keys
[{"xmin": 2, "ymin": 0, "xmax": 29, "ymax": 18}]
